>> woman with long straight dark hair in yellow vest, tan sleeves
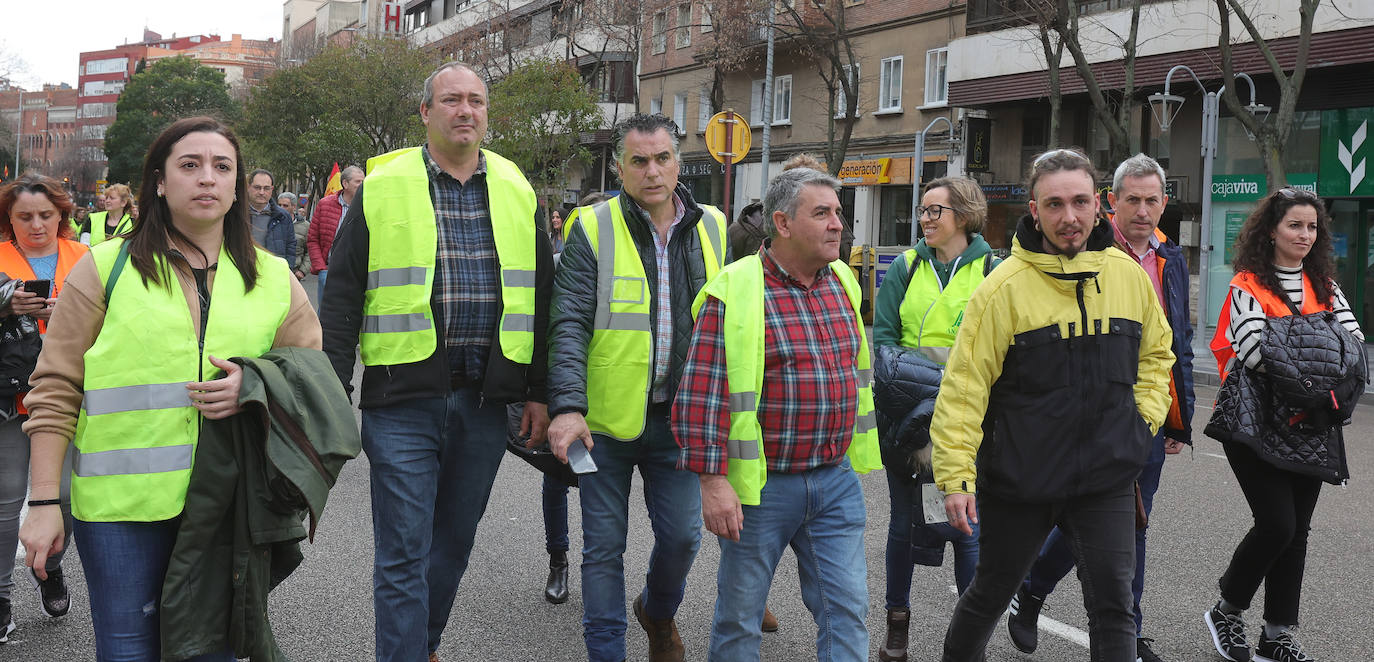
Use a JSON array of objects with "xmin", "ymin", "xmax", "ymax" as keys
[{"xmin": 21, "ymin": 117, "xmax": 320, "ymax": 661}]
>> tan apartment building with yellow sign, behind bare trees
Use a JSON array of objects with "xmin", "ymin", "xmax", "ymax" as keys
[{"xmin": 639, "ymin": 0, "xmax": 967, "ymax": 253}]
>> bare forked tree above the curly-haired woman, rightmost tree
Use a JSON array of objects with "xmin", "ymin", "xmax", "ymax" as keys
[{"xmin": 1216, "ymin": 0, "xmax": 1322, "ymax": 190}]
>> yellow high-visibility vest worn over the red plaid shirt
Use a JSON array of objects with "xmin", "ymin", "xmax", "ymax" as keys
[{"xmin": 692, "ymin": 254, "xmax": 882, "ymax": 505}]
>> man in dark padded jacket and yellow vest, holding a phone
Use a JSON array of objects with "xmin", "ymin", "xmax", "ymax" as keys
[{"xmin": 548, "ymin": 114, "xmax": 728, "ymax": 662}]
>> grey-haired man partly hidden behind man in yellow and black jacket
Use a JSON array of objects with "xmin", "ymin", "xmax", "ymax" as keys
[{"xmin": 1007, "ymin": 154, "xmax": 1194, "ymax": 662}]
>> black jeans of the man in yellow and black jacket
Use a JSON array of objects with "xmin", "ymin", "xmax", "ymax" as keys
[{"xmin": 944, "ymin": 485, "xmax": 1135, "ymax": 662}]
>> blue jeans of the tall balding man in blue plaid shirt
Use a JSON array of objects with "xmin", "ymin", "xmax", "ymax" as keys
[{"xmin": 363, "ymin": 389, "xmax": 506, "ymax": 662}]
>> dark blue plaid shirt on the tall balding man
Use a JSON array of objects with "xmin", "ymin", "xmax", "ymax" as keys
[{"xmin": 422, "ymin": 147, "xmax": 502, "ymax": 385}]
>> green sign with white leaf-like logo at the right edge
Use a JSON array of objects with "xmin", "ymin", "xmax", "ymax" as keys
[{"xmin": 1318, "ymin": 109, "xmax": 1374, "ymax": 198}]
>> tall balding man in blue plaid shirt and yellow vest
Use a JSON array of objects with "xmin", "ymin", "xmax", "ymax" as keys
[{"xmin": 321, "ymin": 65, "xmax": 554, "ymax": 662}]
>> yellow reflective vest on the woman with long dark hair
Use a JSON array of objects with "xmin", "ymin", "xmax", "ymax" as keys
[{"xmin": 71, "ymin": 238, "xmax": 293, "ymax": 522}]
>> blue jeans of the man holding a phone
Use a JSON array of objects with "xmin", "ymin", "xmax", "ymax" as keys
[{"xmin": 578, "ymin": 405, "xmax": 701, "ymax": 662}]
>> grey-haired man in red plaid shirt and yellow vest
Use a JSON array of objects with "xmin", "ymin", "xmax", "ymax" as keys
[{"xmin": 673, "ymin": 168, "xmax": 882, "ymax": 662}]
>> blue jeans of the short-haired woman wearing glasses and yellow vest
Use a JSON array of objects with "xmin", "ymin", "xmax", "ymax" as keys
[{"xmin": 885, "ymin": 471, "xmax": 978, "ymax": 610}]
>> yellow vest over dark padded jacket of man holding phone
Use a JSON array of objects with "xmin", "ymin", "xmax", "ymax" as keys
[{"xmin": 576, "ymin": 196, "xmax": 725, "ymax": 441}]
